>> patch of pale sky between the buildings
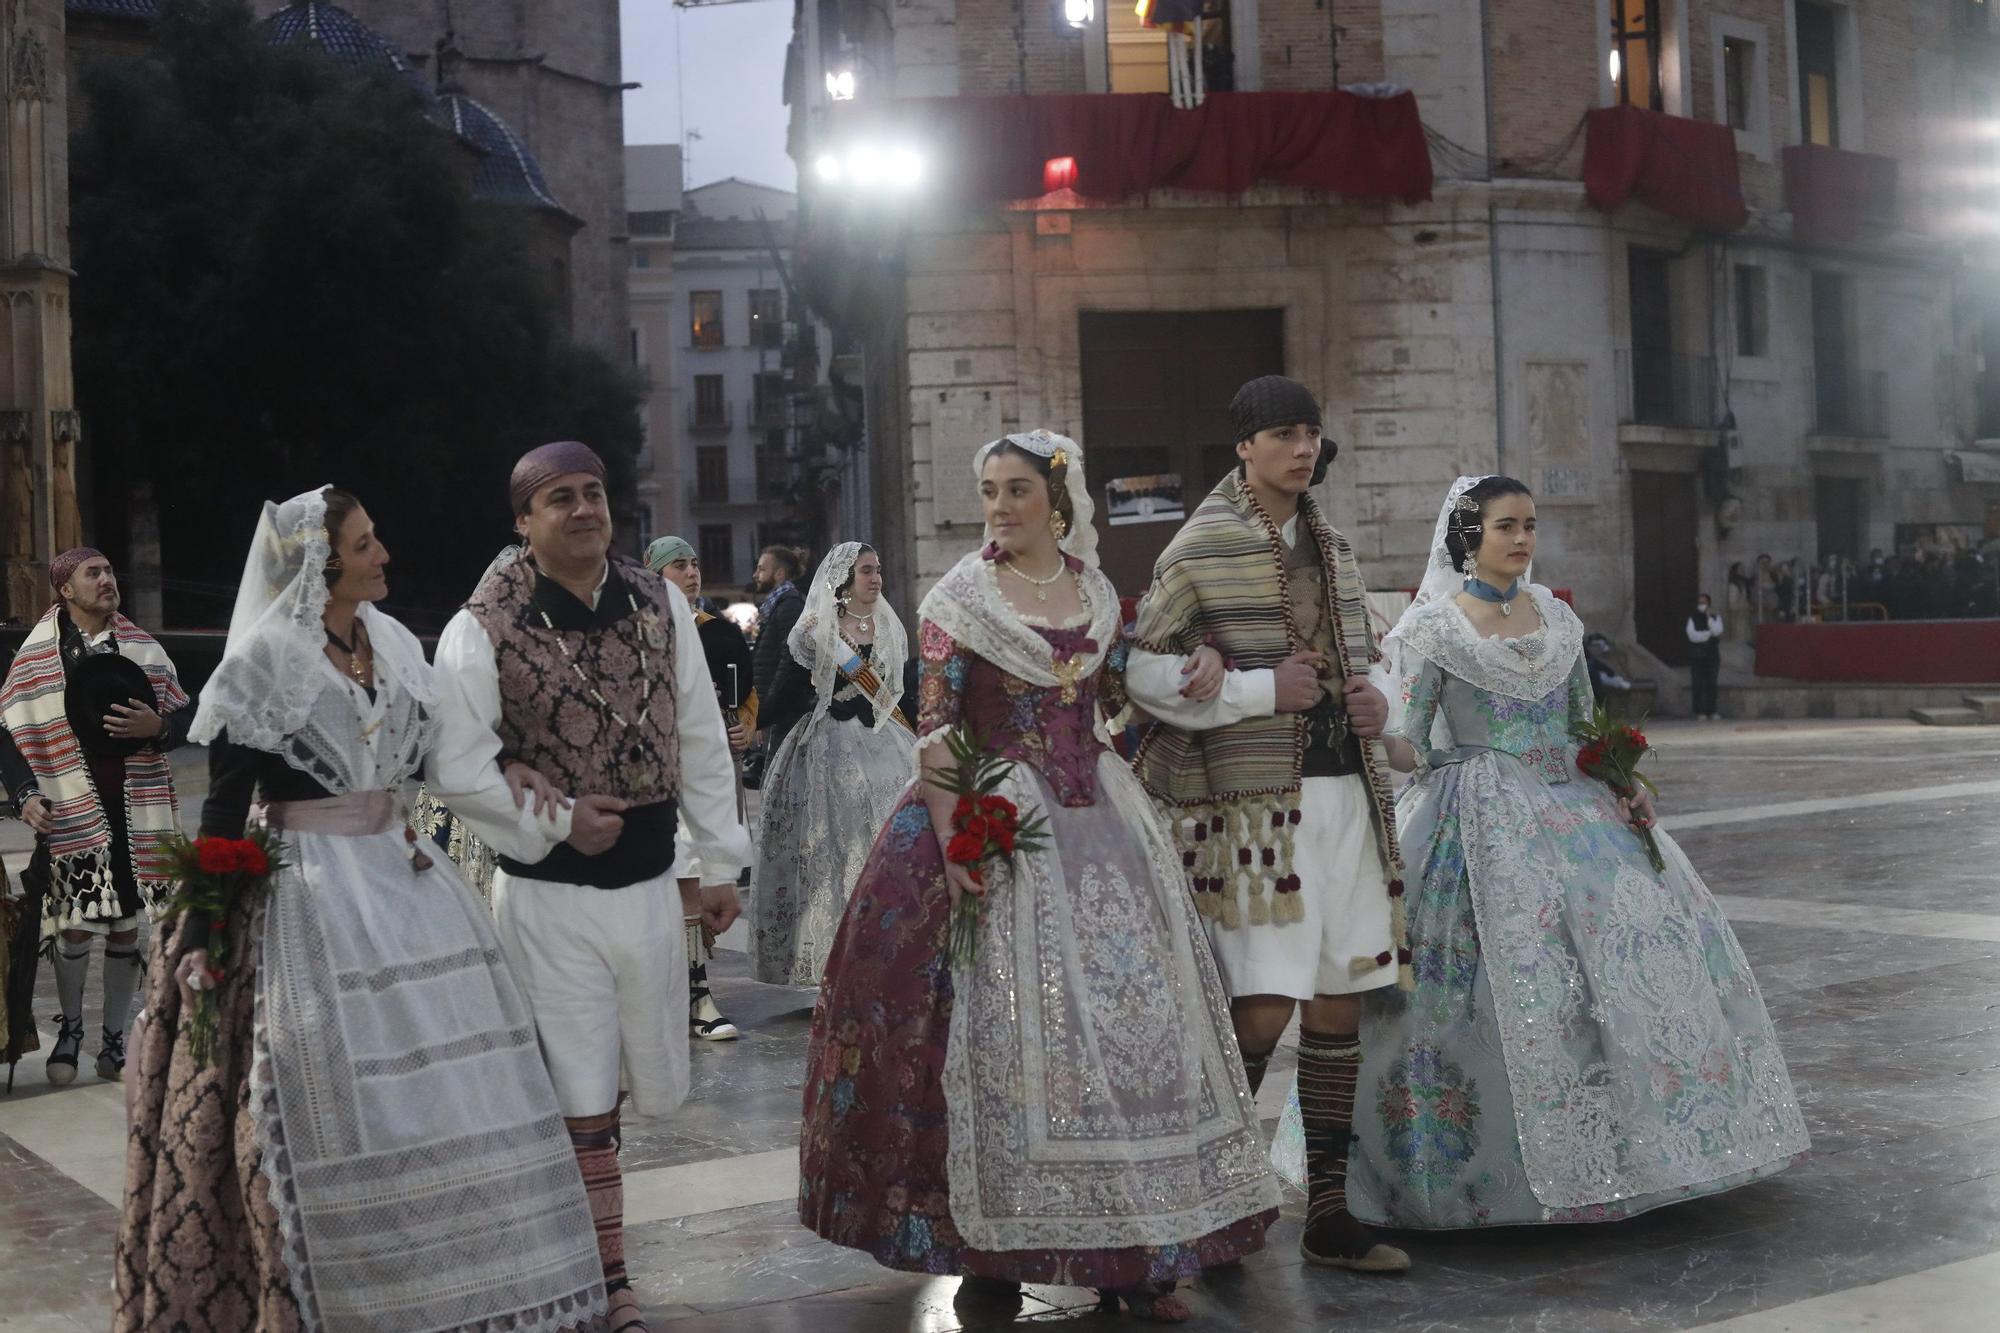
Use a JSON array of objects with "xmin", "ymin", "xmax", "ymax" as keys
[{"xmin": 620, "ymin": 0, "xmax": 798, "ymax": 190}]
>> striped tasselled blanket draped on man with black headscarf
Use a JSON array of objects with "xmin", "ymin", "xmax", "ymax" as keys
[{"xmin": 1134, "ymin": 472, "xmax": 1412, "ymax": 985}]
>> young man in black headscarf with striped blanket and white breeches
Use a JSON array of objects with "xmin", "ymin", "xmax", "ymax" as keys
[{"xmin": 1126, "ymin": 374, "xmax": 1410, "ymax": 1273}]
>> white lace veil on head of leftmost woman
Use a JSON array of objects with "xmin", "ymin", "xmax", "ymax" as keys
[{"xmin": 188, "ymin": 486, "xmax": 436, "ymax": 753}]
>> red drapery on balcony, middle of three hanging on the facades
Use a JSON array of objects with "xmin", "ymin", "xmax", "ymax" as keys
[{"xmin": 1584, "ymin": 106, "xmax": 1750, "ymax": 232}]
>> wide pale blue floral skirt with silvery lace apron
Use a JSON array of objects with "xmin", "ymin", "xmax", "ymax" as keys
[{"xmin": 1328, "ymin": 755, "xmax": 1808, "ymax": 1227}]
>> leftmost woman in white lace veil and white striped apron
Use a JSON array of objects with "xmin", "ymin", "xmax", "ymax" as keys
[{"xmin": 114, "ymin": 488, "xmax": 606, "ymax": 1333}]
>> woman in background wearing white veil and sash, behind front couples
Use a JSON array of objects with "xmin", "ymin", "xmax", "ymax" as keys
[{"xmin": 750, "ymin": 542, "xmax": 914, "ymax": 987}]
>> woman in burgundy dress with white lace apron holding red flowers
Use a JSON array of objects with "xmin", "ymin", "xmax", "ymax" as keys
[{"xmin": 800, "ymin": 430, "xmax": 1278, "ymax": 1323}]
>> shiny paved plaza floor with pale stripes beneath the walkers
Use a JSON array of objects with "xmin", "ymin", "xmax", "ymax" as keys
[{"xmin": 0, "ymin": 723, "xmax": 2000, "ymax": 1333}]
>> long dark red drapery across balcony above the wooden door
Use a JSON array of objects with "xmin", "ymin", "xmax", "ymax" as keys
[{"xmin": 828, "ymin": 92, "xmax": 1432, "ymax": 204}]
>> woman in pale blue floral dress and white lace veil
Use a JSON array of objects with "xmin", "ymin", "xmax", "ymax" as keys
[{"xmin": 1272, "ymin": 476, "xmax": 1808, "ymax": 1229}]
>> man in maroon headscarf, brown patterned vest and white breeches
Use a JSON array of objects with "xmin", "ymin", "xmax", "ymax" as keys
[{"xmin": 426, "ymin": 442, "xmax": 750, "ymax": 1333}]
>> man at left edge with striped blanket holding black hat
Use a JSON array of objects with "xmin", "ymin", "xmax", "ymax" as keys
[{"xmin": 0, "ymin": 546, "xmax": 194, "ymax": 1087}]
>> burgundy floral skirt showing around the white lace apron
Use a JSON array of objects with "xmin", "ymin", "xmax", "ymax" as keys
[{"xmin": 798, "ymin": 791, "xmax": 1276, "ymax": 1287}]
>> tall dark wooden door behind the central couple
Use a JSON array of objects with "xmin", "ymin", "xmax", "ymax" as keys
[{"xmin": 1078, "ymin": 310, "xmax": 1284, "ymax": 596}]
